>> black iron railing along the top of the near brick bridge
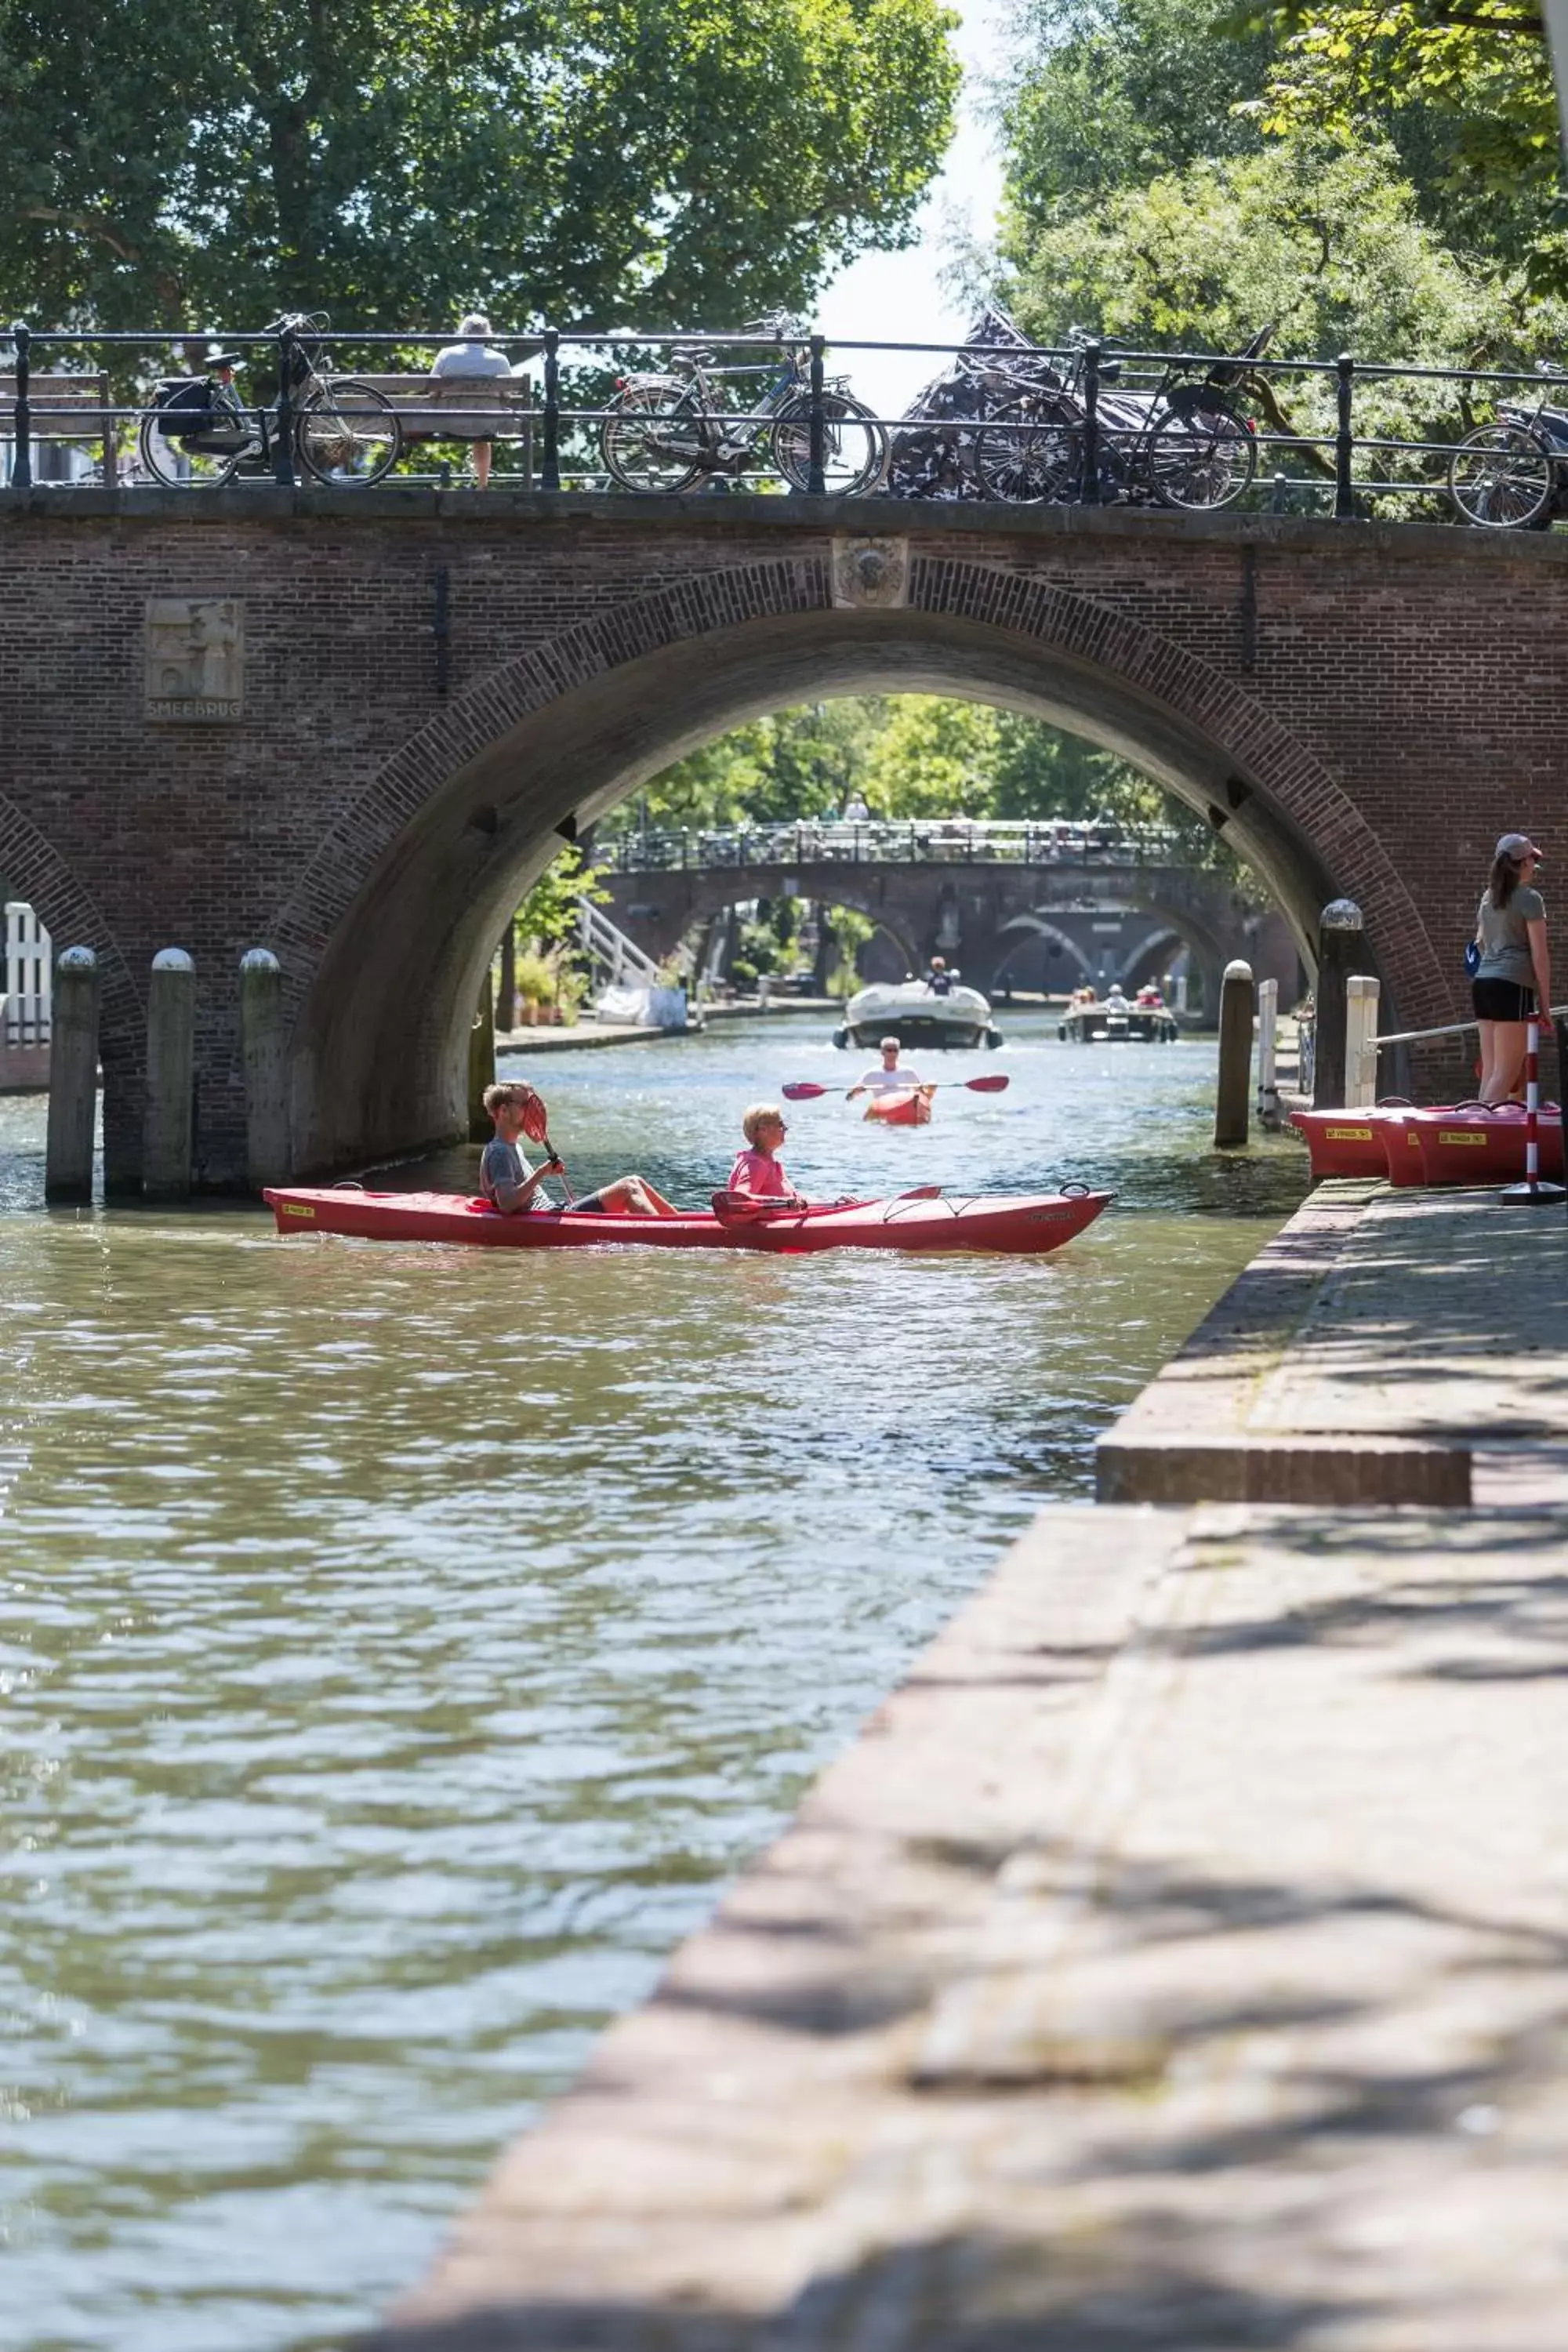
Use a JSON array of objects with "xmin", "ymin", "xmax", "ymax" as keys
[{"xmin": 0, "ymin": 318, "xmax": 1568, "ymax": 529}]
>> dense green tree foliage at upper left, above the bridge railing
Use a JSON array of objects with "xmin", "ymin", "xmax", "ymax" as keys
[{"xmin": 0, "ymin": 0, "xmax": 956, "ymax": 327}]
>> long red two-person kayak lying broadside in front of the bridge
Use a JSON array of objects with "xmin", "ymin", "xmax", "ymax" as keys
[{"xmin": 263, "ymin": 1185, "xmax": 1112, "ymax": 1258}]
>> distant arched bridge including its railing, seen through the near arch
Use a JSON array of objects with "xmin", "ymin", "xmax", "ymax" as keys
[{"xmin": 594, "ymin": 818, "xmax": 1298, "ymax": 1009}]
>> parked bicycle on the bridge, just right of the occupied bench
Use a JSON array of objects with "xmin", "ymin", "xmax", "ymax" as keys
[{"xmin": 600, "ymin": 313, "xmax": 886, "ymax": 499}]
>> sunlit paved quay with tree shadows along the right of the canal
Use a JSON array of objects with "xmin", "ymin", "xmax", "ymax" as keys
[{"xmin": 374, "ymin": 1185, "xmax": 1568, "ymax": 2352}]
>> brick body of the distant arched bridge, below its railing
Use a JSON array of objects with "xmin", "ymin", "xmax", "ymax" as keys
[{"xmin": 607, "ymin": 856, "xmax": 1258, "ymax": 1007}]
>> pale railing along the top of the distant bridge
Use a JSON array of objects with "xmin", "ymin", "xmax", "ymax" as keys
[{"xmin": 595, "ymin": 816, "xmax": 1185, "ymax": 873}]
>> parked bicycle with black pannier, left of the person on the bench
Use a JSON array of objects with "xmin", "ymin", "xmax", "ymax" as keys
[{"xmin": 136, "ymin": 310, "xmax": 402, "ymax": 489}]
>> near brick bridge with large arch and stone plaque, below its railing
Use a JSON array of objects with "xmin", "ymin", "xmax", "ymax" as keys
[{"xmin": 0, "ymin": 487, "xmax": 1542, "ymax": 1183}]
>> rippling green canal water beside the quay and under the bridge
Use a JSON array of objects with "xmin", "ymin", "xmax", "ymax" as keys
[{"xmin": 0, "ymin": 1016, "xmax": 1305, "ymax": 2352}]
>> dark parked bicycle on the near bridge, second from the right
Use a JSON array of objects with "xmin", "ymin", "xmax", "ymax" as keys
[{"xmin": 973, "ymin": 327, "xmax": 1272, "ymax": 513}]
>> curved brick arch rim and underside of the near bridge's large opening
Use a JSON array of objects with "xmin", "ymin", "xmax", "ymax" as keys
[{"xmin": 275, "ymin": 553, "xmax": 1443, "ymax": 1171}]
